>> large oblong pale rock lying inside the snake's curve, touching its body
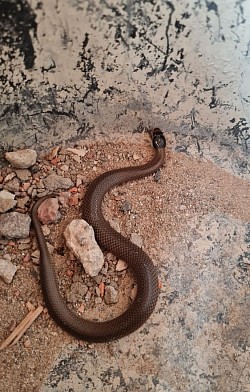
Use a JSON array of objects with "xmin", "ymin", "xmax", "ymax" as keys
[{"xmin": 64, "ymin": 219, "xmax": 104, "ymax": 276}]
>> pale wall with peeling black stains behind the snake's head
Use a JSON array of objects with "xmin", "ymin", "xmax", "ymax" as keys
[{"xmin": 0, "ymin": 0, "xmax": 250, "ymax": 150}]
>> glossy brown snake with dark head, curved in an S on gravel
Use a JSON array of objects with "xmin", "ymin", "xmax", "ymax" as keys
[{"xmin": 31, "ymin": 128, "xmax": 166, "ymax": 342}]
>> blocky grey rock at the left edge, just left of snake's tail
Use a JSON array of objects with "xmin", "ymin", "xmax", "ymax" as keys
[{"xmin": 0, "ymin": 212, "xmax": 31, "ymax": 239}]
